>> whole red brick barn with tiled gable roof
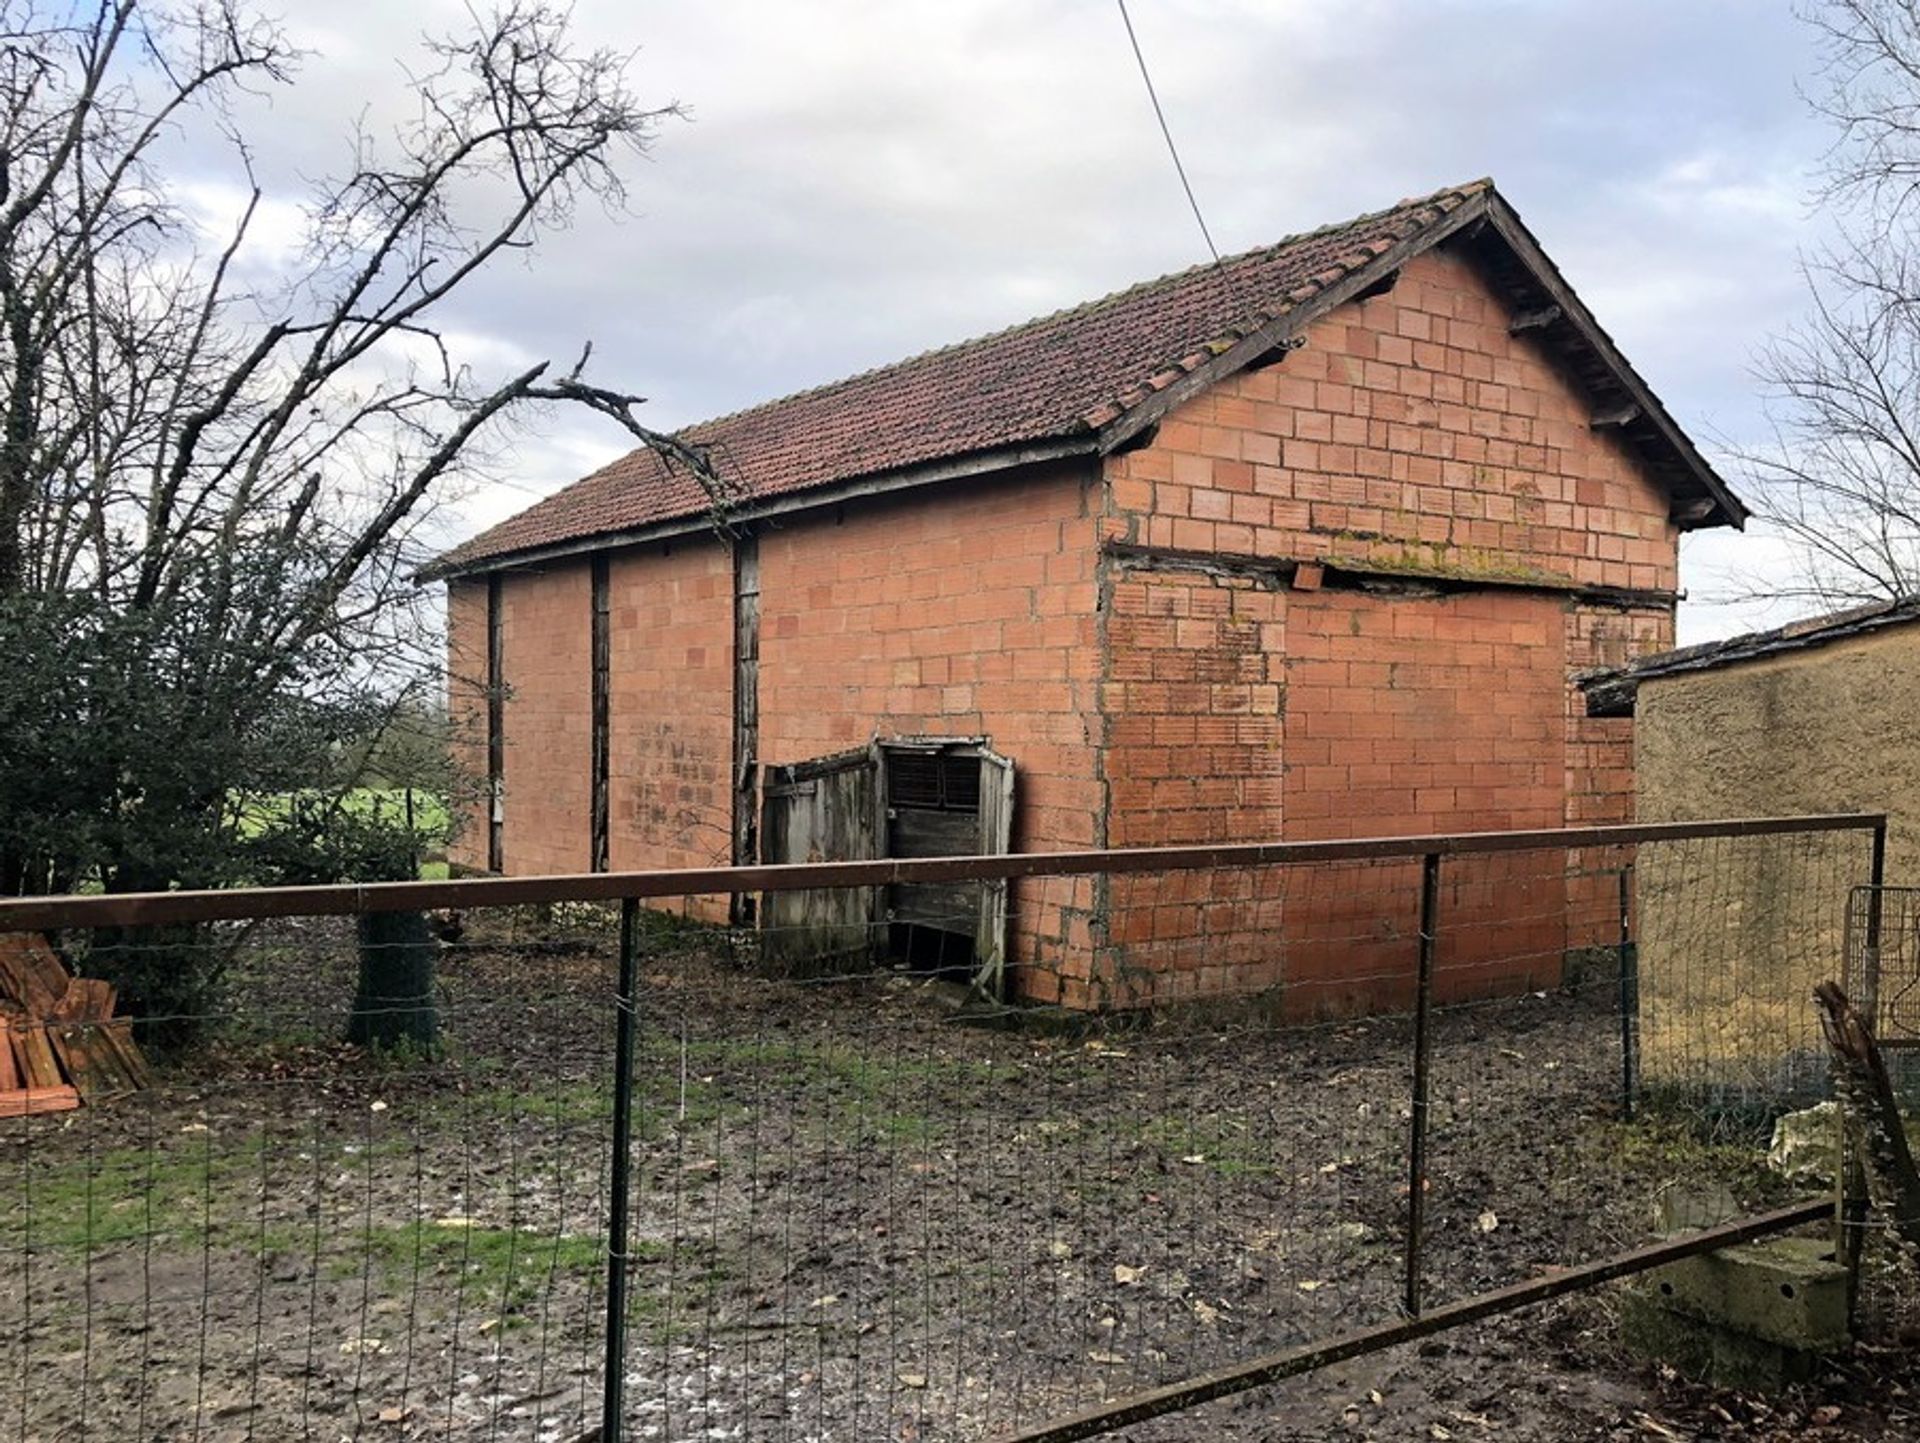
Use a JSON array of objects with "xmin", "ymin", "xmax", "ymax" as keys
[{"xmin": 434, "ymin": 182, "xmax": 1745, "ymax": 1011}]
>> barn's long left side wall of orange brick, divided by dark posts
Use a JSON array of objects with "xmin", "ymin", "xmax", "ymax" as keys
[{"xmin": 449, "ymin": 470, "xmax": 1104, "ymax": 998}]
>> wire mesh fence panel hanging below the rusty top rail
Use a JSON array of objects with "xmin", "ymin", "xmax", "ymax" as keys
[{"xmin": 0, "ymin": 827, "xmax": 1872, "ymax": 1443}]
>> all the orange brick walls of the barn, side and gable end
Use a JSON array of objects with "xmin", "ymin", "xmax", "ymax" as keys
[{"xmin": 451, "ymin": 242, "xmax": 1712, "ymax": 1009}]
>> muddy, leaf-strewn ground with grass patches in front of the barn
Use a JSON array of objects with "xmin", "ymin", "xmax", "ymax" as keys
[{"xmin": 0, "ymin": 919, "xmax": 1920, "ymax": 1443}]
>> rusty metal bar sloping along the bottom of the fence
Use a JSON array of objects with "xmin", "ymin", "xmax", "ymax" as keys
[{"xmin": 998, "ymin": 1201, "xmax": 1834, "ymax": 1443}]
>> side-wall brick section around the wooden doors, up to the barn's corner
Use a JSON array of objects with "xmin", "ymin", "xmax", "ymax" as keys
[{"xmin": 760, "ymin": 468, "xmax": 1104, "ymax": 1000}]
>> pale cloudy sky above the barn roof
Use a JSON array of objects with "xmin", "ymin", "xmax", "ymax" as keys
[{"xmin": 182, "ymin": 0, "xmax": 1828, "ymax": 639}]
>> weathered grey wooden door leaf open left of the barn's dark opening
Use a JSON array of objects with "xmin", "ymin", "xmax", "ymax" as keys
[{"xmin": 760, "ymin": 746, "xmax": 881, "ymax": 977}]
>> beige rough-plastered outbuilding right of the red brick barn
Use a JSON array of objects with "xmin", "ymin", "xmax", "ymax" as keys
[{"xmin": 1580, "ymin": 601, "xmax": 1920, "ymax": 1098}]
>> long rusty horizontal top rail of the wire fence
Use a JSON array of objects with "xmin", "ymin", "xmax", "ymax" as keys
[{"xmin": 0, "ymin": 812, "xmax": 1885, "ymax": 931}]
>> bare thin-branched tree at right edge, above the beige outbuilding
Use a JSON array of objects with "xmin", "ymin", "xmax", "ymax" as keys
[{"xmin": 1738, "ymin": 0, "xmax": 1920, "ymax": 604}]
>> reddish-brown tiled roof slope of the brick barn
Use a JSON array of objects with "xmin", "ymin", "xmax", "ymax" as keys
[{"xmin": 430, "ymin": 180, "xmax": 1492, "ymax": 574}]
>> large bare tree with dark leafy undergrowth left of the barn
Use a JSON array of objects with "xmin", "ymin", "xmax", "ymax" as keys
[{"xmin": 0, "ymin": 0, "xmax": 722, "ymax": 1028}]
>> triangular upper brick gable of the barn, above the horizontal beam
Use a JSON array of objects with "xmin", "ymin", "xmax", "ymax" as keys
[{"xmin": 1108, "ymin": 251, "xmax": 1678, "ymax": 591}]
